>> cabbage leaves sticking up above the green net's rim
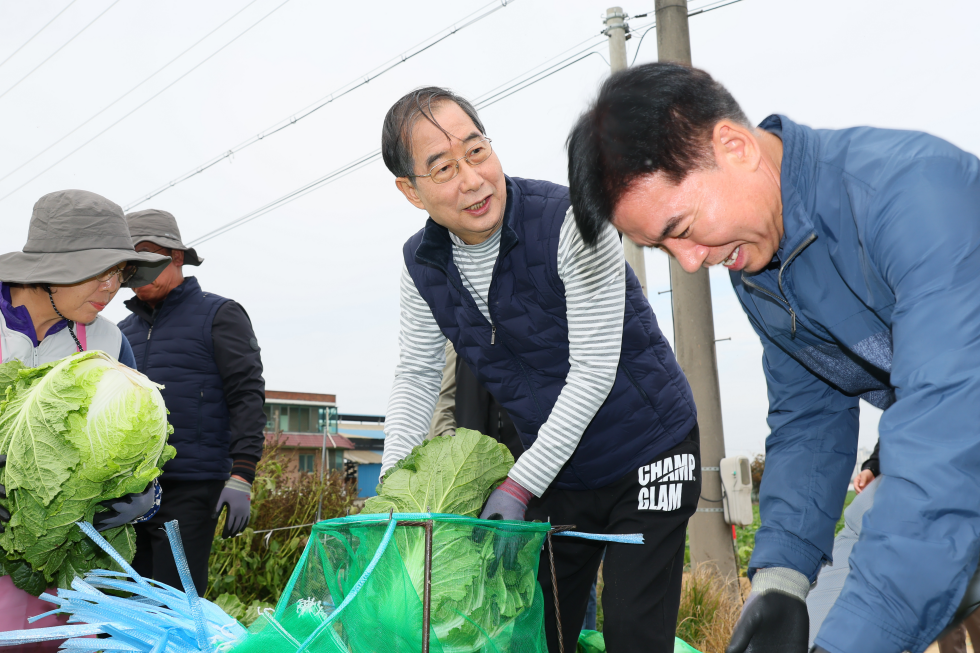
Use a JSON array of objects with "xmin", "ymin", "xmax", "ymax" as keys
[{"xmin": 362, "ymin": 429, "xmax": 514, "ymax": 517}]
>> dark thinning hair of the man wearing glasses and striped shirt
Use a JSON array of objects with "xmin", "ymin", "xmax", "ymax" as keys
[{"xmin": 381, "ymin": 86, "xmax": 486, "ymax": 181}]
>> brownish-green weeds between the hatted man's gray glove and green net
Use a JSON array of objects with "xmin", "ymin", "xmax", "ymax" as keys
[{"xmin": 205, "ymin": 441, "xmax": 357, "ymax": 608}]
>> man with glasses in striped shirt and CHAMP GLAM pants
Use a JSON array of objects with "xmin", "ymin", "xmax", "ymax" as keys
[{"xmin": 382, "ymin": 87, "xmax": 701, "ymax": 653}]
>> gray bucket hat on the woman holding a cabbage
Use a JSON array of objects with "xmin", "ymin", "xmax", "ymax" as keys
[{"xmin": 0, "ymin": 190, "xmax": 170, "ymax": 288}]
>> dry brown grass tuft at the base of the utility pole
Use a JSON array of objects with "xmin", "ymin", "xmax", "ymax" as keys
[{"xmin": 677, "ymin": 564, "xmax": 742, "ymax": 653}]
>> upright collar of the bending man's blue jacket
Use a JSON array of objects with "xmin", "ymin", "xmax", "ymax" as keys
[{"xmin": 759, "ymin": 114, "xmax": 817, "ymax": 262}]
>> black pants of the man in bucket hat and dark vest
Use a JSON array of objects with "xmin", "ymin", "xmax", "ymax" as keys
[{"xmin": 133, "ymin": 479, "xmax": 225, "ymax": 596}]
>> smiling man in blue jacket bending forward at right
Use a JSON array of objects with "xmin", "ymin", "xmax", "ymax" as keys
[{"xmin": 569, "ymin": 64, "xmax": 980, "ymax": 653}]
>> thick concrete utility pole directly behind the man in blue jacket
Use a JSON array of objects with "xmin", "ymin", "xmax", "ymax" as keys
[{"xmin": 655, "ymin": 0, "xmax": 737, "ymax": 578}]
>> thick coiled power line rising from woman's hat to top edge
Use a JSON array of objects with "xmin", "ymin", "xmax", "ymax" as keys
[{"xmin": 125, "ymin": 0, "xmax": 516, "ymax": 211}]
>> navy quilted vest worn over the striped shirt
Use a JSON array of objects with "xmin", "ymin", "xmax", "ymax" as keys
[{"xmin": 403, "ymin": 177, "xmax": 697, "ymax": 490}]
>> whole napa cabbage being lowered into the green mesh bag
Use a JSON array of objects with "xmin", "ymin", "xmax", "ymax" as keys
[{"xmin": 362, "ymin": 429, "xmax": 548, "ymax": 653}]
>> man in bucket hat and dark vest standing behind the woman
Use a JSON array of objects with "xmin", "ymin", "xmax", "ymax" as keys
[{"xmin": 119, "ymin": 209, "xmax": 265, "ymax": 593}]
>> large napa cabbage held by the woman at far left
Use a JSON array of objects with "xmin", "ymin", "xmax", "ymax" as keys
[{"xmin": 0, "ymin": 351, "xmax": 174, "ymax": 594}]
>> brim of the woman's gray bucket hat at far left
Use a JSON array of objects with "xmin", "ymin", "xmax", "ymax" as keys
[{"xmin": 0, "ymin": 249, "xmax": 170, "ymax": 288}]
